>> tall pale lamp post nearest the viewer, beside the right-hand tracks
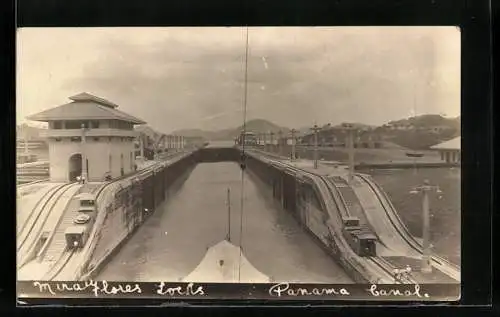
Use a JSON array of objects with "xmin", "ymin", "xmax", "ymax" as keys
[{"xmin": 410, "ymin": 180, "xmax": 442, "ymax": 273}]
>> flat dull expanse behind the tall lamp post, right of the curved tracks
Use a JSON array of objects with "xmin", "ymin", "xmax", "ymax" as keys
[{"xmin": 370, "ymin": 168, "xmax": 461, "ymax": 264}]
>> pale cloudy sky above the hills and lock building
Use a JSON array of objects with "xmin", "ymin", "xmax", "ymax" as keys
[{"xmin": 17, "ymin": 27, "xmax": 460, "ymax": 133}]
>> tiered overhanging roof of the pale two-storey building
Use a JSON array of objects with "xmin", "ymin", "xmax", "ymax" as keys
[{"xmin": 27, "ymin": 93, "xmax": 146, "ymax": 124}]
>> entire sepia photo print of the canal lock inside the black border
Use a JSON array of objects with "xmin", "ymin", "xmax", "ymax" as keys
[{"xmin": 16, "ymin": 27, "xmax": 461, "ymax": 300}]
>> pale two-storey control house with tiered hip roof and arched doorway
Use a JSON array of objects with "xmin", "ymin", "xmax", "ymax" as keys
[{"xmin": 27, "ymin": 93, "xmax": 146, "ymax": 182}]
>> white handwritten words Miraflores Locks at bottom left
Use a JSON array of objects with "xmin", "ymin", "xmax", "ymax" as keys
[{"xmin": 33, "ymin": 281, "xmax": 205, "ymax": 297}]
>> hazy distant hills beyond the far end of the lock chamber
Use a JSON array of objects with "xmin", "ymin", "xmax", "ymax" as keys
[{"xmin": 172, "ymin": 119, "xmax": 290, "ymax": 141}]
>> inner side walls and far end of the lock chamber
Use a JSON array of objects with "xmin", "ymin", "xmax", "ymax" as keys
[{"xmin": 84, "ymin": 149, "xmax": 372, "ymax": 280}]
